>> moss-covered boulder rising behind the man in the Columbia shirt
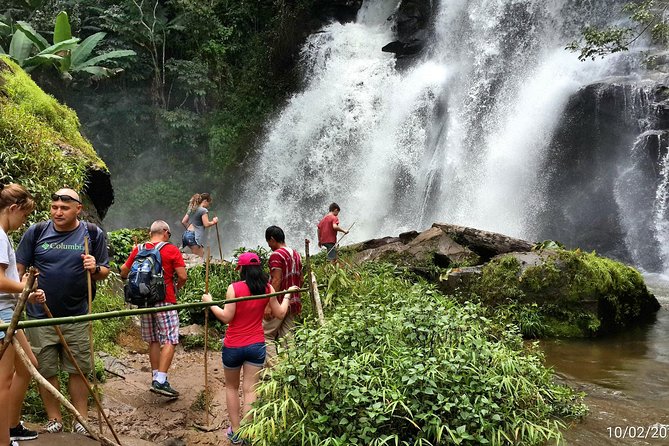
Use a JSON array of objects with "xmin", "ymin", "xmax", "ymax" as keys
[{"xmin": 0, "ymin": 56, "xmax": 114, "ymax": 220}]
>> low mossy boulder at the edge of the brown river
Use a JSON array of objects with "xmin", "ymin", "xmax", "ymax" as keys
[{"xmin": 463, "ymin": 250, "xmax": 651, "ymax": 337}]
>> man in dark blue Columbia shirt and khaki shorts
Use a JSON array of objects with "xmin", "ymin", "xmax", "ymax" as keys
[{"xmin": 16, "ymin": 189, "xmax": 109, "ymax": 434}]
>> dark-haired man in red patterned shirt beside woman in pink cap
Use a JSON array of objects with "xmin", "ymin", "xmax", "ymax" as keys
[{"xmin": 263, "ymin": 226, "xmax": 302, "ymax": 367}]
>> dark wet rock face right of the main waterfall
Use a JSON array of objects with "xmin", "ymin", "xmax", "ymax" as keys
[{"xmin": 540, "ymin": 77, "xmax": 669, "ymax": 271}]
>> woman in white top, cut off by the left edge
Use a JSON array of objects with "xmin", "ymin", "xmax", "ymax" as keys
[{"xmin": 0, "ymin": 184, "xmax": 46, "ymax": 446}]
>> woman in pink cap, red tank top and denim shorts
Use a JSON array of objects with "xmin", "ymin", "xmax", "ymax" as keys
[{"xmin": 202, "ymin": 252, "xmax": 296, "ymax": 444}]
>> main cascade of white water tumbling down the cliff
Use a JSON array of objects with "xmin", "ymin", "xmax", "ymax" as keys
[{"xmin": 232, "ymin": 0, "xmax": 648, "ymax": 258}]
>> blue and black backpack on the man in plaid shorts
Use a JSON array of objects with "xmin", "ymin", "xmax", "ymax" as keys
[{"xmin": 123, "ymin": 242, "xmax": 167, "ymax": 308}]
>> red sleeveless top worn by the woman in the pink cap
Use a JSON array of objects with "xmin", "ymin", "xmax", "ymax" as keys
[{"xmin": 223, "ymin": 281, "xmax": 269, "ymax": 348}]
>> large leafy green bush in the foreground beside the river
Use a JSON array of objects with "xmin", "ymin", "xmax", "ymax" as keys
[{"xmin": 242, "ymin": 264, "xmax": 585, "ymax": 445}]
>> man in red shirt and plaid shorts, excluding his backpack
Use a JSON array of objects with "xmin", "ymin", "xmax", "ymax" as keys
[{"xmin": 121, "ymin": 220, "xmax": 187, "ymax": 398}]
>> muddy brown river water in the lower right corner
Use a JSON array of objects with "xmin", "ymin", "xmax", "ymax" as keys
[{"xmin": 542, "ymin": 274, "xmax": 669, "ymax": 446}]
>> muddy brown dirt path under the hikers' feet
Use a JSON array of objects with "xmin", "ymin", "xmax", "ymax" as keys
[{"xmin": 96, "ymin": 326, "xmax": 228, "ymax": 446}]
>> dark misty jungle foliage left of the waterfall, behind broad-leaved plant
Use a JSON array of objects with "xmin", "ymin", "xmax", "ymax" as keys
[{"xmin": 0, "ymin": 0, "xmax": 324, "ymax": 226}]
